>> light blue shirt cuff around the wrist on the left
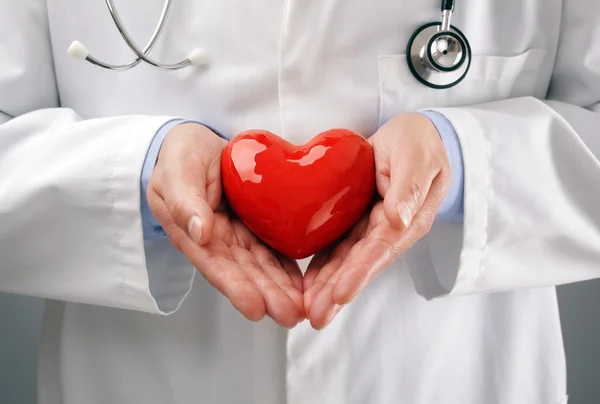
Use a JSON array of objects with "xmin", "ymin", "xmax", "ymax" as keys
[{"xmin": 140, "ymin": 119, "xmax": 227, "ymax": 240}]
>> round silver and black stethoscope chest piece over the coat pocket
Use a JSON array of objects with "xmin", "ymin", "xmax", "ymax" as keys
[{"xmin": 406, "ymin": 22, "xmax": 471, "ymax": 89}]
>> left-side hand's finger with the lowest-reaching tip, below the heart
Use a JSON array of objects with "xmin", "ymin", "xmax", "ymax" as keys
[{"xmin": 231, "ymin": 246, "xmax": 300, "ymax": 328}]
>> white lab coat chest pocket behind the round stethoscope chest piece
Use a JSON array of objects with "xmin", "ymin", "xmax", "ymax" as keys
[{"xmin": 378, "ymin": 49, "xmax": 546, "ymax": 125}]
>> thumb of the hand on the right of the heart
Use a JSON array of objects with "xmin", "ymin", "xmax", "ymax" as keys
[{"xmin": 383, "ymin": 160, "xmax": 438, "ymax": 230}]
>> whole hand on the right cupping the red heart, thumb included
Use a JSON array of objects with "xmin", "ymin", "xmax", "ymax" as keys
[{"xmin": 304, "ymin": 113, "xmax": 450, "ymax": 329}]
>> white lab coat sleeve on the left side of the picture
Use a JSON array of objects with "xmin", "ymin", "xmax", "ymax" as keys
[{"xmin": 0, "ymin": 0, "xmax": 196, "ymax": 314}]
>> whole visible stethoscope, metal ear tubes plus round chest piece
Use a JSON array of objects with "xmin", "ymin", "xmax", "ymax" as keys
[{"xmin": 67, "ymin": 0, "xmax": 471, "ymax": 89}]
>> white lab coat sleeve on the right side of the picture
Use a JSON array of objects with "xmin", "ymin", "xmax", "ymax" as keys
[{"xmin": 405, "ymin": 0, "xmax": 600, "ymax": 299}]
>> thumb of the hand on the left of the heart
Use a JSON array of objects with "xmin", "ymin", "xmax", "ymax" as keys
[{"xmin": 163, "ymin": 183, "xmax": 214, "ymax": 245}]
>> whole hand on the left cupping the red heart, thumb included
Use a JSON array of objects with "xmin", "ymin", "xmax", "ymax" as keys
[{"xmin": 147, "ymin": 123, "xmax": 304, "ymax": 328}]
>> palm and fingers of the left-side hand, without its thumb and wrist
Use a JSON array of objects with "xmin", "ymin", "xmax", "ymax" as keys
[{"xmin": 191, "ymin": 205, "xmax": 304, "ymax": 328}]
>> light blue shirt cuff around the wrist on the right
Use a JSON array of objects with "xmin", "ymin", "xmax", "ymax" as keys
[{"xmin": 420, "ymin": 111, "xmax": 464, "ymax": 222}]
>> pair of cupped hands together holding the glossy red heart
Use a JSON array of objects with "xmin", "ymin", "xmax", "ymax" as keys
[{"xmin": 147, "ymin": 113, "xmax": 450, "ymax": 329}]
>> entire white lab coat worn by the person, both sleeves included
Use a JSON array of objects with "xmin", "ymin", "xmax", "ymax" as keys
[{"xmin": 0, "ymin": 0, "xmax": 600, "ymax": 404}]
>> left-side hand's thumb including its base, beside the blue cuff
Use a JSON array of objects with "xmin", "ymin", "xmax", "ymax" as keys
[{"xmin": 156, "ymin": 170, "xmax": 214, "ymax": 245}]
